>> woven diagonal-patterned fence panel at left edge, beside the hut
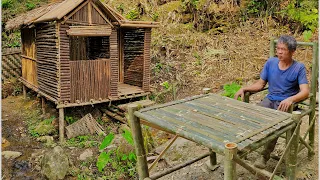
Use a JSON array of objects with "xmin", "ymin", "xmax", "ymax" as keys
[{"xmin": 1, "ymin": 48, "xmax": 21, "ymax": 81}]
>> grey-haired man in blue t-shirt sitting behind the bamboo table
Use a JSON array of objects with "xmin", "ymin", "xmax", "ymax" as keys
[{"xmin": 234, "ymin": 35, "xmax": 309, "ymax": 169}]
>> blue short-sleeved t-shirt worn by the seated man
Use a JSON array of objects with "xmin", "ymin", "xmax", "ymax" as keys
[{"xmin": 260, "ymin": 57, "xmax": 308, "ymax": 101}]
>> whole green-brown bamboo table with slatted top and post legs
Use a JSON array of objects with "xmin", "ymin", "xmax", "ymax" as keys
[{"xmin": 129, "ymin": 94, "xmax": 299, "ymax": 180}]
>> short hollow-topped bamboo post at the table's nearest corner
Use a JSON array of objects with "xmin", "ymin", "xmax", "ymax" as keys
[{"xmin": 224, "ymin": 143, "xmax": 237, "ymax": 180}]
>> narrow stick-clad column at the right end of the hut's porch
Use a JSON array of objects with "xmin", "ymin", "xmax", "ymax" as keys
[{"xmin": 142, "ymin": 28, "xmax": 151, "ymax": 91}]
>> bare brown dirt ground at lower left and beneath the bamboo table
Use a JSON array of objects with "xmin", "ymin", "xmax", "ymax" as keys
[{"xmin": 1, "ymin": 91, "xmax": 318, "ymax": 180}]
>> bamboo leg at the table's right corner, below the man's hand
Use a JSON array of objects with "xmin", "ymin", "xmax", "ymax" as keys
[{"xmin": 286, "ymin": 111, "xmax": 301, "ymax": 180}]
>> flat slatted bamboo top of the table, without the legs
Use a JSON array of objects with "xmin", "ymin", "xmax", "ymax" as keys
[{"xmin": 134, "ymin": 94, "xmax": 293, "ymax": 154}]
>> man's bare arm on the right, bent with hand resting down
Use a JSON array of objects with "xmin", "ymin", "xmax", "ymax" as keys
[{"xmin": 278, "ymin": 84, "xmax": 309, "ymax": 112}]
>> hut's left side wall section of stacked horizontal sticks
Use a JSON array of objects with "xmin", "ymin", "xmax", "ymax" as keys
[{"xmin": 36, "ymin": 23, "xmax": 59, "ymax": 100}]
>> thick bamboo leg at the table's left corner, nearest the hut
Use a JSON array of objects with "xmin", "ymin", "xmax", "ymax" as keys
[{"xmin": 128, "ymin": 104, "xmax": 149, "ymax": 179}]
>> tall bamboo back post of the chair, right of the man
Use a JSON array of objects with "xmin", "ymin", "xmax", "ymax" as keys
[{"xmin": 308, "ymin": 42, "xmax": 319, "ymax": 159}]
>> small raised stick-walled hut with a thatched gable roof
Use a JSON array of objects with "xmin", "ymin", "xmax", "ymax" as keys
[{"xmin": 6, "ymin": 0, "xmax": 158, "ymax": 139}]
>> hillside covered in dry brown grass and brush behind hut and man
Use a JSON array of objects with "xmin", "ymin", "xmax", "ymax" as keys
[{"xmin": 2, "ymin": 0, "xmax": 318, "ymax": 102}]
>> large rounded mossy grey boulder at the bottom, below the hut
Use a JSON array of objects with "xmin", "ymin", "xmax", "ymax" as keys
[{"xmin": 41, "ymin": 146, "xmax": 69, "ymax": 180}]
